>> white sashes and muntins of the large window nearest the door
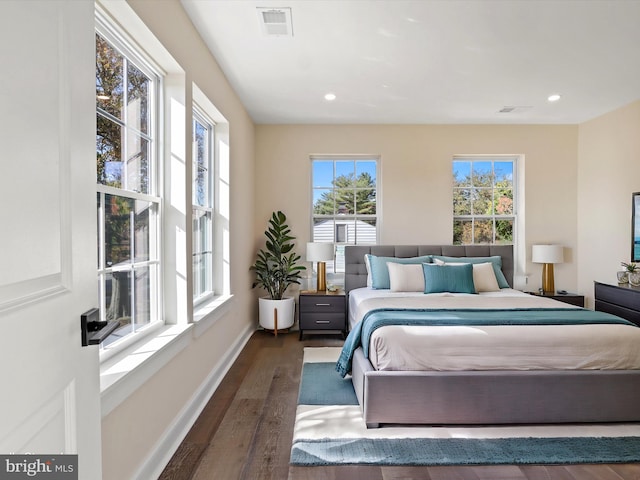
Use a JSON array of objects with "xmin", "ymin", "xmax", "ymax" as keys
[{"xmin": 96, "ymin": 26, "xmax": 162, "ymax": 346}]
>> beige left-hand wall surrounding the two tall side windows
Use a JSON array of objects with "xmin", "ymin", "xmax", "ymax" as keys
[{"xmin": 102, "ymin": 0, "xmax": 257, "ymax": 480}]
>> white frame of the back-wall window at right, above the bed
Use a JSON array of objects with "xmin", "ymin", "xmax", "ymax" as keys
[{"xmin": 451, "ymin": 155, "xmax": 520, "ymax": 245}]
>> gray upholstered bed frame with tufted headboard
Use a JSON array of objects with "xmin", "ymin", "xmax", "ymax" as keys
[{"xmin": 345, "ymin": 245, "xmax": 640, "ymax": 428}]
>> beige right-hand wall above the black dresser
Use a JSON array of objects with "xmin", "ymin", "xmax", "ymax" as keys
[{"xmin": 578, "ymin": 101, "xmax": 640, "ymax": 306}]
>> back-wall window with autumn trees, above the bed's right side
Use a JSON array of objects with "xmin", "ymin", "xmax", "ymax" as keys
[{"xmin": 453, "ymin": 157, "xmax": 517, "ymax": 245}]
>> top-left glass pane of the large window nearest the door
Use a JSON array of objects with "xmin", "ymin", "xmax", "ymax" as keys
[{"xmin": 96, "ymin": 35, "xmax": 124, "ymax": 119}]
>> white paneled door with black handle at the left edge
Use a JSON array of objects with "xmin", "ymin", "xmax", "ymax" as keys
[{"xmin": 0, "ymin": 0, "xmax": 101, "ymax": 480}]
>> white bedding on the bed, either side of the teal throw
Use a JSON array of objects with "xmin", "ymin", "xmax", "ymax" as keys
[{"xmin": 349, "ymin": 288, "xmax": 640, "ymax": 371}]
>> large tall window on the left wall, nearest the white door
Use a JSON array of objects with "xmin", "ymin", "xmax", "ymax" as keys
[{"xmin": 96, "ymin": 32, "xmax": 160, "ymax": 344}]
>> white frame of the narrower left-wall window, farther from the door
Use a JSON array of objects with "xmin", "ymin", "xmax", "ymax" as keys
[{"xmin": 192, "ymin": 107, "xmax": 216, "ymax": 307}]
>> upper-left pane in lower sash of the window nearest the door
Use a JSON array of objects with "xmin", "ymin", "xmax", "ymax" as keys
[{"xmin": 104, "ymin": 195, "xmax": 134, "ymax": 267}]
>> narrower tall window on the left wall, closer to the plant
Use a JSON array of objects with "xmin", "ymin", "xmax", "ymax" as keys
[{"xmin": 193, "ymin": 109, "xmax": 214, "ymax": 303}]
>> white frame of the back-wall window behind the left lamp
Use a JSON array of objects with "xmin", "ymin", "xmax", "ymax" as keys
[{"xmin": 310, "ymin": 155, "xmax": 380, "ymax": 284}]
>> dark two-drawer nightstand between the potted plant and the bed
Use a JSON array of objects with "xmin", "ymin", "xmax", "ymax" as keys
[{"xmin": 299, "ymin": 290, "xmax": 347, "ymax": 340}]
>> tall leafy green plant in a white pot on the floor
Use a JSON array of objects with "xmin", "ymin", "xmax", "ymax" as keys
[{"xmin": 250, "ymin": 211, "xmax": 306, "ymax": 333}]
